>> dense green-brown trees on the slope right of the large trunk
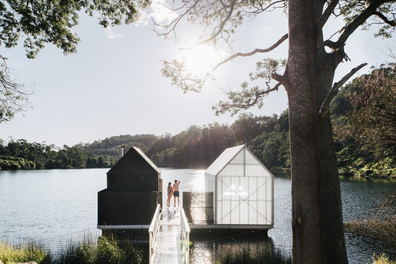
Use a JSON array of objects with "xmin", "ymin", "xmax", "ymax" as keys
[{"xmin": 332, "ymin": 64, "xmax": 396, "ymax": 179}]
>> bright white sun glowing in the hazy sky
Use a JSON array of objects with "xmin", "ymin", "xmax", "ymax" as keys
[{"xmin": 184, "ymin": 45, "xmax": 221, "ymax": 74}]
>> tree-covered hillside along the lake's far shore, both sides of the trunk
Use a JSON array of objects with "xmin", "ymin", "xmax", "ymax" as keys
[{"xmin": 0, "ymin": 64, "xmax": 396, "ymax": 178}]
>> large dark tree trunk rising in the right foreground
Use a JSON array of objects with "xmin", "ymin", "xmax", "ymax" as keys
[{"xmin": 285, "ymin": 0, "xmax": 348, "ymax": 264}]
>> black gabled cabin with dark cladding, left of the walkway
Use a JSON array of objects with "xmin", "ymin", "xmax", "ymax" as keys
[{"xmin": 98, "ymin": 147, "xmax": 162, "ymax": 230}]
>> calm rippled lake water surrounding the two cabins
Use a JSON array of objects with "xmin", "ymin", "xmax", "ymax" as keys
[{"xmin": 0, "ymin": 169, "xmax": 396, "ymax": 263}]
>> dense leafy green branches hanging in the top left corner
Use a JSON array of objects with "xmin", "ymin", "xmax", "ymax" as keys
[{"xmin": 0, "ymin": 0, "xmax": 150, "ymax": 58}]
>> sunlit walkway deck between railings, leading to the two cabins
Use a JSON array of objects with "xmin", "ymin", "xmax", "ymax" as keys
[{"xmin": 153, "ymin": 206, "xmax": 182, "ymax": 264}]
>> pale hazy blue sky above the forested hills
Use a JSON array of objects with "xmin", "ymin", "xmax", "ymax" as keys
[{"xmin": 0, "ymin": 3, "xmax": 394, "ymax": 147}]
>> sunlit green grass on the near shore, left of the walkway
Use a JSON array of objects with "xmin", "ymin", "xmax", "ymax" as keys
[{"xmin": 0, "ymin": 237, "xmax": 147, "ymax": 264}]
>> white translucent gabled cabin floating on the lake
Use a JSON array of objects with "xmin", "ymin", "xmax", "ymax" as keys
[{"xmin": 205, "ymin": 145, "xmax": 274, "ymax": 229}]
